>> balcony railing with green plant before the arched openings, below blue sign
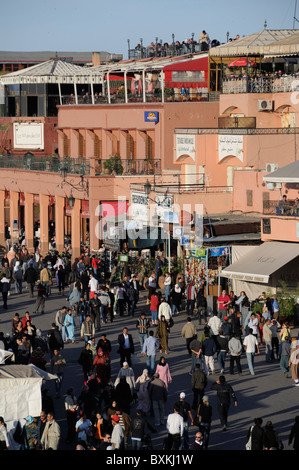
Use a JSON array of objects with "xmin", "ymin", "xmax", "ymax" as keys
[{"xmin": 95, "ymin": 158, "xmax": 161, "ymax": 176}]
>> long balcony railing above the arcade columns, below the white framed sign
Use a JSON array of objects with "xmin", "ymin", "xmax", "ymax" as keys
[{"xmin": 0, "ymin": 154, "xmax": 90, "ymax": 175}]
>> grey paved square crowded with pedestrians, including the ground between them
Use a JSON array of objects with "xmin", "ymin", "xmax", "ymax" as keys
[{"xmin": 0, "ymin": 244, "xmax": 297, "ymax": 450}]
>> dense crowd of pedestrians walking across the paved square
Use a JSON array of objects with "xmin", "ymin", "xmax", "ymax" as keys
[{"xmin": 0, "ymin": 242, "xmax": 299, "ymax": 451}]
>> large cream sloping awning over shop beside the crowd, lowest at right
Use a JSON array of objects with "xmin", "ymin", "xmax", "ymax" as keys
[{"xmin": 221, "ymin": 242, "xmax": 299, "ymax": 284}]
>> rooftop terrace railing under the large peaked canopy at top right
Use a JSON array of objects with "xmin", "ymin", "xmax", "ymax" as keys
[{"xmin": 222, "ymin": 74, "xmax": 299, "ymax": 94}]
